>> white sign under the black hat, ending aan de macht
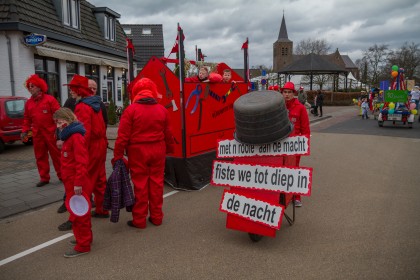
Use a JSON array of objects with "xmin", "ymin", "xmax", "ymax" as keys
[{"xmin": 217, "ymin": 136, "xmax": 309, "ymax": 158}]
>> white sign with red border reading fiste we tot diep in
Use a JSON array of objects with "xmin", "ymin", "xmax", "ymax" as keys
[{"xmin": 211, "ymin": 160, "xmax": 312, "ymax": 196}]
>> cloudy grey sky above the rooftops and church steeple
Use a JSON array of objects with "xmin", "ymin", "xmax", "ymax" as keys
[{"xmin": 88, "ymin": 0, "xmax": 420, "ymax": 68}]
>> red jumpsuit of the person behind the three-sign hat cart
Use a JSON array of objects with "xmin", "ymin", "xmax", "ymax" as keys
[{"xmin": 286, "ymin": 98, "xmax": 311, "ymax": 201}]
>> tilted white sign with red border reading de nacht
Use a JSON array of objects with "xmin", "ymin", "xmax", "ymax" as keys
[{"xmin": 220, "ymin": 190, "xmax": 283, "ymax": 229}]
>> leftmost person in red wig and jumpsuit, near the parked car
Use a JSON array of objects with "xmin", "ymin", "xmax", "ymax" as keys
[{"xmin": 21, "ymin": 74, "xmax": 61, "ymax": 187}]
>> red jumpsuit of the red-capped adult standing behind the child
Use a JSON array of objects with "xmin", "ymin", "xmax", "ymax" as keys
[{"xmin": 74, "ymin": 102, "xmax": 109, "ymax": 215}]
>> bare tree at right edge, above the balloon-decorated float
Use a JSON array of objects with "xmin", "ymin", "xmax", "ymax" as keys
[{"xmin": 385, "ymin": 42, "xmax": 420, "ymax": 79}]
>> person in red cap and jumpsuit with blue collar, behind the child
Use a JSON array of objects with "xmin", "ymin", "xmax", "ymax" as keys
[{"xmin": 64, "ymin": 74, "xmax": 109, "ymax": 218}]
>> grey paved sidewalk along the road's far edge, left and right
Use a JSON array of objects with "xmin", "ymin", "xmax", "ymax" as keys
[{"xmin": 0, "ymin": 106, "xmax": 356, "ymax": 219}]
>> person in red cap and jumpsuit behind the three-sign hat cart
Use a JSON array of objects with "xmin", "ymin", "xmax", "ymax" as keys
[{"xmin": 280, "ymin": 82, "xmax": 311, "ymax": 207}]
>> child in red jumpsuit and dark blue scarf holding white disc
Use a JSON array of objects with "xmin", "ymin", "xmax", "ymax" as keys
[{"xmin": 54, "ymin": 108, "xmax": 92, "ymax": 258}]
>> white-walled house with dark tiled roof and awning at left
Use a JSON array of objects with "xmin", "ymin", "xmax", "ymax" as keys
[{"xmin": 0, "ymin": 0, "xmax": 131, "ymax": 106}]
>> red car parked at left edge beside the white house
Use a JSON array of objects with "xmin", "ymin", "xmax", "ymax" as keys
[{"xmin": 0, "ymin": 96, "xmax": 32, "ymax": 153}]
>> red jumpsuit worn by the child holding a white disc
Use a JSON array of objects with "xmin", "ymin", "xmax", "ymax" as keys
[{"xmin": 61, "ymin": 133, "xmax": 92, "ymax": 252}]
